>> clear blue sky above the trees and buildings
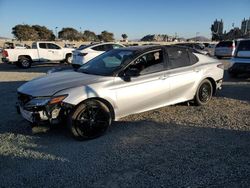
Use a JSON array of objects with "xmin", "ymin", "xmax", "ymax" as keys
[{"xmin": 0, "ymin": 0, "xmax": 250, "ymax": 39}]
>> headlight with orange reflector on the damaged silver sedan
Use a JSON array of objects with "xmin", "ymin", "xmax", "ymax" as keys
[{"xmin": 25, "ymin": 95, "xmax": 67, "ymax": 109}]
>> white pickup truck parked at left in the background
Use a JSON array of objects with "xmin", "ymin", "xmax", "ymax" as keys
[{"xmin": 2, "ymin": 42, "xmax": 74, "ymax": 68}]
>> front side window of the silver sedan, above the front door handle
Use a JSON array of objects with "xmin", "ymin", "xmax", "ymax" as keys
[{"xmin": 128, "ymin": 50, "xmax": 164, "ymax": 75}]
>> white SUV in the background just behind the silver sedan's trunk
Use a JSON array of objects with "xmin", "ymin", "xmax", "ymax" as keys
[{"xmin": 214, "ymin": 40, "xmax": 237, "ymax": 59}]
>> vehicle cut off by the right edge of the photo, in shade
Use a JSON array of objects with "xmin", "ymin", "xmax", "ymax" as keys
[{"xmin": 228, "ymin": 39, "xmax": 250, "ymax": 77}]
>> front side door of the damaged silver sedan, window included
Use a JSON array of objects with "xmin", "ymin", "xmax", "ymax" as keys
[{"xmin": 114, "ymin": 50, "xmax": 169, "ymax": 116}]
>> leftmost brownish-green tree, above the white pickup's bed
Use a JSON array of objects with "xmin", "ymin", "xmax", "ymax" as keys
[{"xmin": 12, "ymin": 25, "xmax": 38, "ymax": 41}]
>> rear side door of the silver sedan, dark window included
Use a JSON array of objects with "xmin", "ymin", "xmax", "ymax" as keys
[{"xmin": 166, "ymin": 47, "xmax": 201, "ymax": 104}]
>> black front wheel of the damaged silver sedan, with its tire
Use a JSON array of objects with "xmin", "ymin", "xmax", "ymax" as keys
[{"xmin": 68, "ymin": 100, "xmax": 112, "ymax": 140}]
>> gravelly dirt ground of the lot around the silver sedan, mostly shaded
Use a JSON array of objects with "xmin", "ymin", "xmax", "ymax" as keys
[{"xmin": 0, "ymin": 60, "xmax": 250, "ymax": 187}]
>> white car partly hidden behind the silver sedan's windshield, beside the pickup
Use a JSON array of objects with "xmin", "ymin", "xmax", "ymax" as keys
[{"xmin": 72, "ymin": 42, "xmax": 125, "ymax": 68}]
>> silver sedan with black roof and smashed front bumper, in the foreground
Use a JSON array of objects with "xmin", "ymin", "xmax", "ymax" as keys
[{"xmin": 17, "ymin": 46, "xmax": 224, "ymax": 140}]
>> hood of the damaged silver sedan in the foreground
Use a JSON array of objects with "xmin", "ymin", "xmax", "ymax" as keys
[{"xmin": 17, "ymin": 70, "xmax": 103, "ymax": 97}]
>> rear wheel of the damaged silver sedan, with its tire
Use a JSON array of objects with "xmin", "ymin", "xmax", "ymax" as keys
[{"xmin": 194, "ymin": 79, "xmax": 213, "ymax": 106}]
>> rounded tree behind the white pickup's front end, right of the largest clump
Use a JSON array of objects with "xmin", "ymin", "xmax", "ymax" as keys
[{"xmin": 58, "ymin": 27, "xmax": 81, "ymax": 41}]
